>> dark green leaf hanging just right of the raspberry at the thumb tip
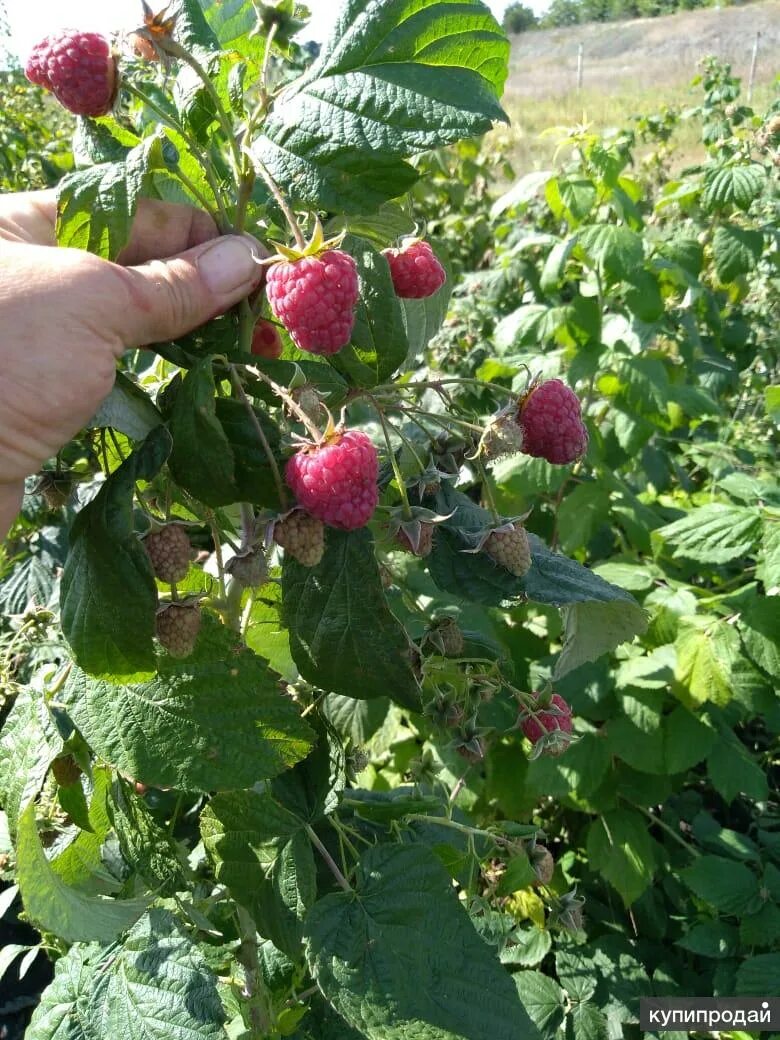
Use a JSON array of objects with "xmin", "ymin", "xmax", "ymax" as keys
[{"xmin": 330, "ymin": 235, "xmax": 409, "ymax": 387}]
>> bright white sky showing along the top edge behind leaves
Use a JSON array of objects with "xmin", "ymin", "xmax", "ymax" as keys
[{"xmin": 0, "ymin": 0, "xmax": 548, "ymax": 59}]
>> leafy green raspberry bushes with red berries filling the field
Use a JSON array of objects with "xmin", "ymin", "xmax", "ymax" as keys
[{"xmin": 0, "ymin": 0, "xmax": 780, "ymax": 1040}]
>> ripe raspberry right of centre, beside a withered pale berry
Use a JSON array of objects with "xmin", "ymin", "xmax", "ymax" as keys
[{"xmin": 519, "ymin": 380, "xmax": 588, "ymax": 465}]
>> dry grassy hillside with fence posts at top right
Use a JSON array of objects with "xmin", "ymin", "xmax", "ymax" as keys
[{"xmin": 499, "ymin": 0, "xmax": 780, "ymax": 170}]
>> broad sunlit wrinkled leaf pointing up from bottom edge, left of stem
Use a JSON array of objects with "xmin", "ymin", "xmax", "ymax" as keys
[{"xmin": 86, "ymin": 909, "xmax": 225, "ymax": 1040}]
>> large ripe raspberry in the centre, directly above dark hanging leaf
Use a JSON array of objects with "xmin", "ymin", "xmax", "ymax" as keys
[{"xmin": 285, "ymin": 430, "xmax": 380, "ymax": 530}]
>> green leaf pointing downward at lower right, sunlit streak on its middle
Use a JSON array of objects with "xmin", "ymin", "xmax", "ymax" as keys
[{"xmin": 588, "ymin": 809, "xmax": 655, "ymax": 907}]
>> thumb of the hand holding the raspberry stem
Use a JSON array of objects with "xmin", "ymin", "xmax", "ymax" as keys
[{"xmin": 113, "ymin": 235, "xmax": 265, "ymax": 347}]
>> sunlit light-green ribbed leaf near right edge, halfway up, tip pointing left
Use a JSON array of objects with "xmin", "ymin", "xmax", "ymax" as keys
[{"xmin": 653, "ymin": 502, "xmax": 761, "ymax": 564}]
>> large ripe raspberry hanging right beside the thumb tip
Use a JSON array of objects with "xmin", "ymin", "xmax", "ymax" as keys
[{"xmin": 265, "ymin": 250, "xmax": 360, "ymax": 354}]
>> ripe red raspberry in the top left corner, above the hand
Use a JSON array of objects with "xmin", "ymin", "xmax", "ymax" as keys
[{"xmin": 25, "ymin": 29, "xmax": 116, "ymax": 115}]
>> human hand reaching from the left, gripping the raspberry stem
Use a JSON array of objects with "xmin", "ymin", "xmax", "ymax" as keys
[{"xmin": 0, "ymin": 191, "xmax": 262, "ymax": 536}]
